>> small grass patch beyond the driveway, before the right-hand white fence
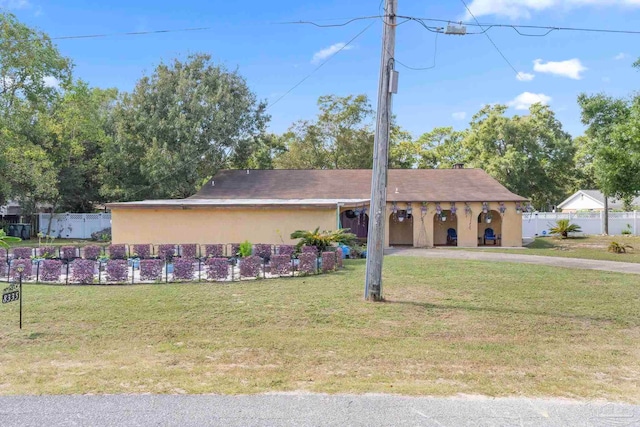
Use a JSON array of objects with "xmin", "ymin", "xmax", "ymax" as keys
[{"xmin": 461, "ymin": 236, "xmax": 640, "ymax": 263}]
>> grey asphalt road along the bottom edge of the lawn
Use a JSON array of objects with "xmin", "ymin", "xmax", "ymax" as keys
[{"xmin": 0, "ymin": 393, "xmax": 640, "ymax": 427}]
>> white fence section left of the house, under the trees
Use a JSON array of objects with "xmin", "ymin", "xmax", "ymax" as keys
[{"xmin": 38, "ymin": 213, "xmax": 111, "ymax": 239}]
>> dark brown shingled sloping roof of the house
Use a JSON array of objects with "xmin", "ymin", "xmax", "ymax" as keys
[{"xmin": 191, "ymin": 169, "xmax": 527, "ymax": 202}]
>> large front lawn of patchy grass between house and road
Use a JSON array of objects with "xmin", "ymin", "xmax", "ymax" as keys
[{"xmin": 0, "ymin": 257, "xmax": 640, "ymax": 403}]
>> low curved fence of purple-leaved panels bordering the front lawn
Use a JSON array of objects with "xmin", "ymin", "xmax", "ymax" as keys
[{"xmin": 0, "ymin": 244, "xmax": 343, "ymax": 284}]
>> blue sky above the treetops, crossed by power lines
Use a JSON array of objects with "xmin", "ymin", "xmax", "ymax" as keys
[{"xmin": 5, "ymin": 0, "xmax": 640, "ymax": 136}]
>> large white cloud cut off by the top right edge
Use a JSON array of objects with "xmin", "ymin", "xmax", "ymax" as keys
[{"xmin": 464, "ymin": 0, "xmax": 640, "ymax": 19}]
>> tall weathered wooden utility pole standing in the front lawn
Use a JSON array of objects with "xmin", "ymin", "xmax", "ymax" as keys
[{"xmin": 365, "ymin": 0, "xmax": 398, "ymax": 301}]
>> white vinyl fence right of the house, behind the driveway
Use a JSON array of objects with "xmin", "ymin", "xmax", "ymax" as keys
[{"xmin": 522, "ymin": 211, "xmax": 640, "ymax": 237}]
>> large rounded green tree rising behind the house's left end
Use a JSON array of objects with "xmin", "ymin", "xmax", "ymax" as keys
[{"xmin": 101, "ymin": 54, "xmax": 269, "ymax": 200}]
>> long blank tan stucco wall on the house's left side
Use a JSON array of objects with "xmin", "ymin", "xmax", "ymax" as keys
[{"xmin": 111, "ymin": 208, "xmax": 336, "ymax": 244}]
